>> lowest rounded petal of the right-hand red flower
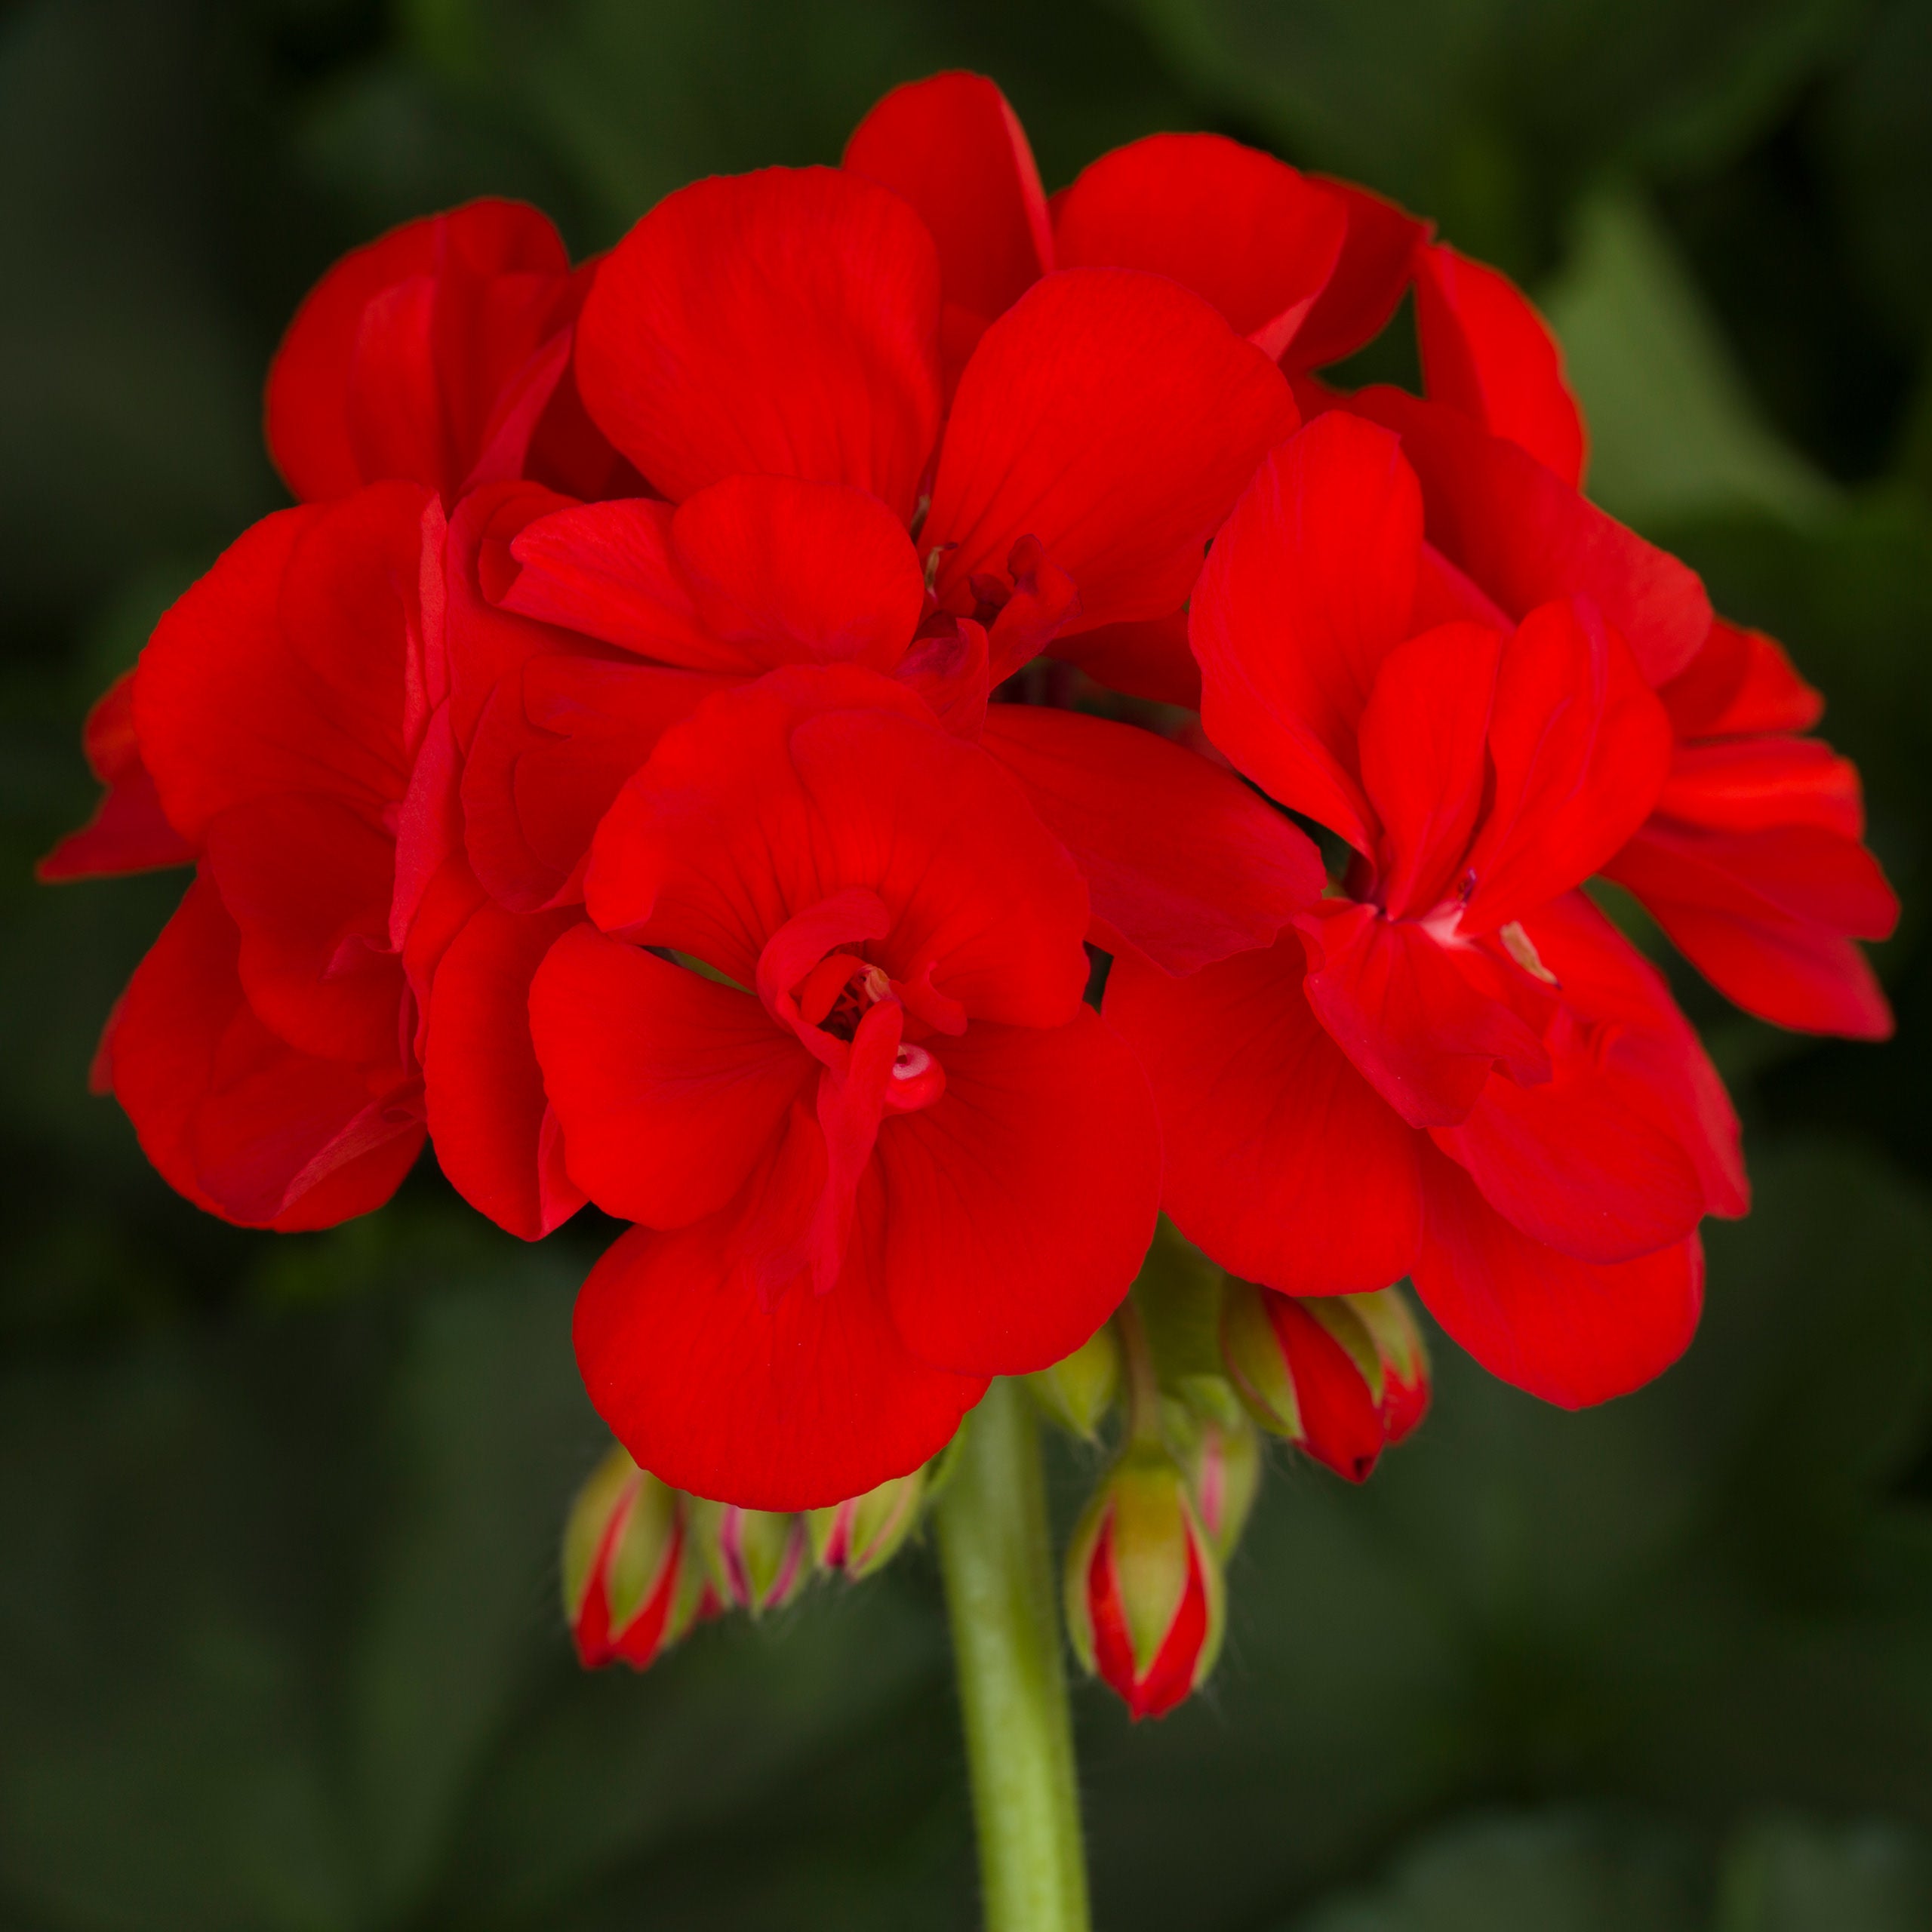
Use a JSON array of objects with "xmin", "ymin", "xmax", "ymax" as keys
[{"xmin": 1414, "ymin": 1152, "xmax": 1704, "ymax": 1408}]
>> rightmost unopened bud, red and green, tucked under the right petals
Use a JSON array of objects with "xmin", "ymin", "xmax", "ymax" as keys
[{"xmin": 1221, "ymin": 1281, "xmax": 1429, "ymax": 1482}]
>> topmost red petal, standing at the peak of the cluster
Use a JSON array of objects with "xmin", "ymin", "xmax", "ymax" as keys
[{"xmin": 844, "ymin": 73, "xmax": 1053, "ymax": 327}]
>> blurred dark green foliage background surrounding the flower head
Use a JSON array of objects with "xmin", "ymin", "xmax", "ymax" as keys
[{"xmin": 0, "ymin": 0, "xmax": 1932, "ymax": 1932}]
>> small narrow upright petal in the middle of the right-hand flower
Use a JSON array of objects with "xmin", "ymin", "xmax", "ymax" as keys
[{"xmin": 1360, "ymin": 624, "xmax": 1503, "ymax": 920}]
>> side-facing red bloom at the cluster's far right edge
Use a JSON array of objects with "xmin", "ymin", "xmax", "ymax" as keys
[{"xmin": 1605, "ymin": 620, "xmax": 1899, "ymax": 1039}]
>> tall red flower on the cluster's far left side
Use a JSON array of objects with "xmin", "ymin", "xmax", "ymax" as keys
[{"xmin": 91, "ymin": 483, "xmax": 442, "ymax": 1229}]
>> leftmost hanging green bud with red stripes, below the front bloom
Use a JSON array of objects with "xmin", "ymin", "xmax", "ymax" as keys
[{"xmin": 565, "ymin": 1447, "xmax": 697, "ymax": 1671}]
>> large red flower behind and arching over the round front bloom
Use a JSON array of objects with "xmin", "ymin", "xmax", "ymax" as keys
[{"xmin": 398, "ymin": 154, "xmax": 1319, "ymax": 1235}]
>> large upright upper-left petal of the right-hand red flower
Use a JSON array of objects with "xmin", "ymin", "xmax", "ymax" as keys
[{"xmin": 1188, "ymin": 411, "xmax": 1422, "ymax": 852}]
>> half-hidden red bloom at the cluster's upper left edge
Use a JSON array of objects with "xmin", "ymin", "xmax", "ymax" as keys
[{"xmin": 266, "ymin": 201, "xmax": 635, "ymax": 506}]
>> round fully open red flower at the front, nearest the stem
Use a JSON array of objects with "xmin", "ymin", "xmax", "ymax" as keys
[{"xmin": 531, "ymin": 666, "xmax": 1159, "ymax": 1509}]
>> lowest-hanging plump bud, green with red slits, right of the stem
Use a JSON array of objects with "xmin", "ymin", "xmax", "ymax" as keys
[{"xmin": 1066, "ymin": 1441, "xmax": 1225, "ymax": 1719}]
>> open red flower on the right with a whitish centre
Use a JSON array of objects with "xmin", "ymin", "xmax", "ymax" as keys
[{"xmin": 1107, "ymin": 414, "xmax": 1745, "ymax": 1403}]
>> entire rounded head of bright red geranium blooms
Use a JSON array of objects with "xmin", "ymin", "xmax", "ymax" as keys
[{"xmin": 42, "ymin": 73, "xmax": 1895, "ymax": 1708}]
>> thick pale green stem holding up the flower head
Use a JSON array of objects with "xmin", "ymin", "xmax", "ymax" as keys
[{"xmin": 935, "ymin": 1380, "xmax": 1088, "ymax": 1932}]
